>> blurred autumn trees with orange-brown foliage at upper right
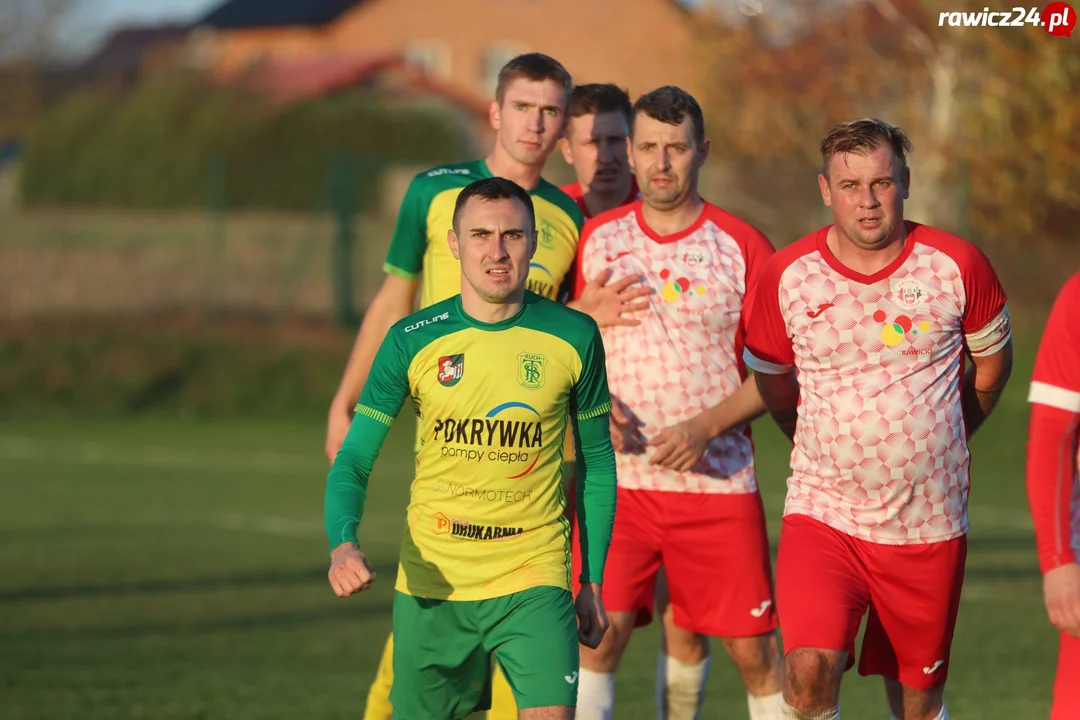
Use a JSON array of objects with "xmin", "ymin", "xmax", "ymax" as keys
[{"xmin": 700, "ymin": 0, "xmax": 1080, "ymax": 249}]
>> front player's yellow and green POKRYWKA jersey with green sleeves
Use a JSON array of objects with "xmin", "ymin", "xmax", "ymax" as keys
[{"xmin": 326, "ymin": 293, "xmax": 615, "ymax": 600}]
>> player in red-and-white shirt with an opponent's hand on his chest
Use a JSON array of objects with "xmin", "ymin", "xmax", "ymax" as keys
[{"xmin": 571, "ymin": 87, "xmax": 783, "ymax": 720}]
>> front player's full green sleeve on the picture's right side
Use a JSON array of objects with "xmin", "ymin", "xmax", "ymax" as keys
[{"xmin": 571, "ymin": 324, "xmax": 617, "ymax": 583}]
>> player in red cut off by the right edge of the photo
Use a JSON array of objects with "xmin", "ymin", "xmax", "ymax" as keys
[{"xmin": 1027, "ymin": 272, "xmax": 1080, "ymax": 720}]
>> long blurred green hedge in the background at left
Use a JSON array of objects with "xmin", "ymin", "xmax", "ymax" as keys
[{"xmin": 21, "ymin": 77, "xmax": 475, "ymax": 210}]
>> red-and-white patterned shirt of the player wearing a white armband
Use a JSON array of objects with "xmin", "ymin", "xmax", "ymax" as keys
[{"xmin": 745, "ymin": 221, "xmax": 1011, "ymax": 545}]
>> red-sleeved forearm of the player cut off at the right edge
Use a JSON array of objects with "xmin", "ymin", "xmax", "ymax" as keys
[{"xmin": 1027, "ymin": 404, "xmax": 1080, "ymax": 573}]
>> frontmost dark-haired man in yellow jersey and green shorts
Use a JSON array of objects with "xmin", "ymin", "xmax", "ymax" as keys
[{"xmin": 325, "ymin": 177, "xmax": 616, "ymax": 720}]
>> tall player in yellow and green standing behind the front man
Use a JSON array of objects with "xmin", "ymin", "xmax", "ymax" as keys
[{"xmin": 324, "ymin": 53, "xmax": 636, "ymax": 720}]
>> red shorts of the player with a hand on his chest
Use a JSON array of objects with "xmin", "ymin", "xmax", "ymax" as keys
[{"xmin": 571, "ymin": 488, "xmax": 778, "ymax": 638}]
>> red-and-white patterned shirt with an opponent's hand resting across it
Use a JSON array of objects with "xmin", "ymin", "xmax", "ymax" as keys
[{"xmin": 575, "ymin": 200, "xmax": 774, "ymax": 493}]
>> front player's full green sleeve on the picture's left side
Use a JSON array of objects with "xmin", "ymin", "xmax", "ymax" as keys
[{"xmin": 323, "ymin": 328, "xmax": 408, "ymax": 551}]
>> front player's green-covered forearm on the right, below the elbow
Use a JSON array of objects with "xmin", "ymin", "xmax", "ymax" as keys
[{"xmin": 577, "ymin": 412, "xmax": 617, "ymax": 583}]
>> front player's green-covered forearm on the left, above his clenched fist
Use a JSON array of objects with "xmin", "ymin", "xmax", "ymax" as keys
[{"xmin": 323, "ymin": 415, "xmax": 390, "ymax": 552}]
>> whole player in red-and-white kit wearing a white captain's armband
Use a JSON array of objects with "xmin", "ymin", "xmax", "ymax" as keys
[{"xmin": 745, "ymin": 118, "xmax": 1012, "ymax": 720}]
